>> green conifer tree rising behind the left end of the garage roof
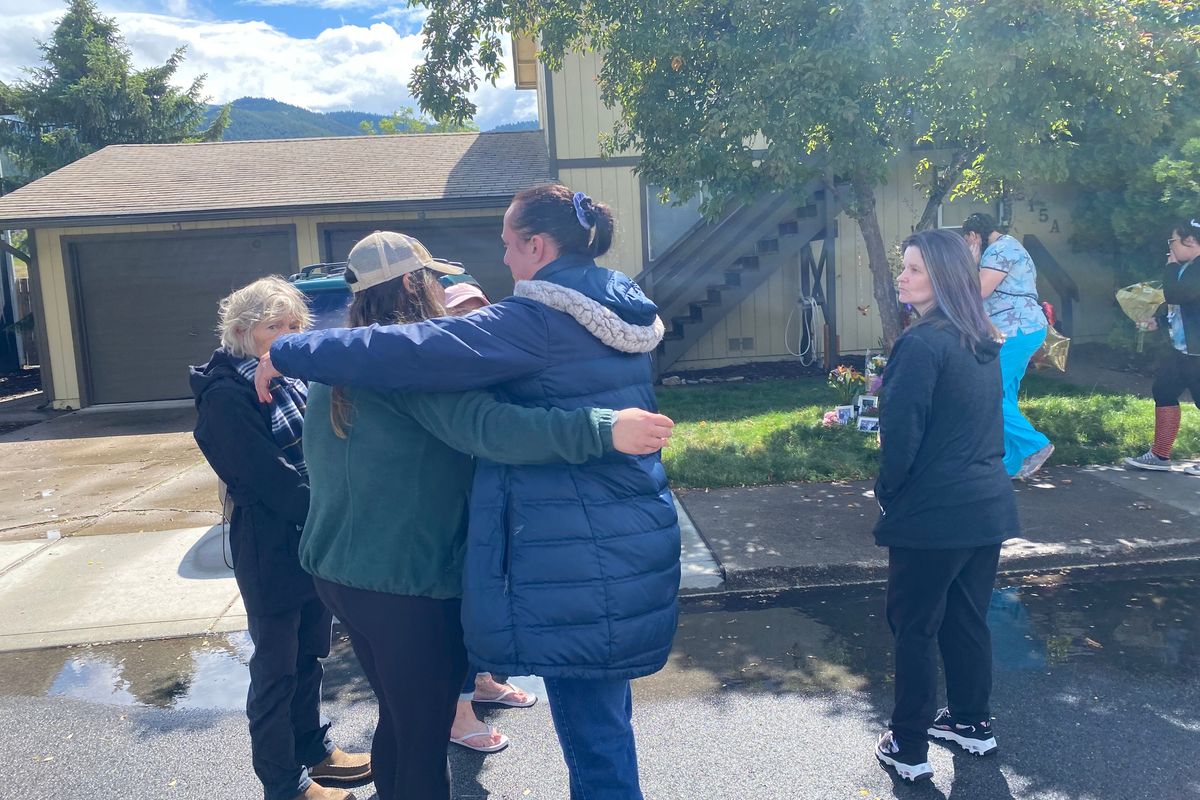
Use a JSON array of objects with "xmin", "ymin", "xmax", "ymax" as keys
[{"xmin": 0, "ymin": 0, "xmax": 229, "ymax": 180}]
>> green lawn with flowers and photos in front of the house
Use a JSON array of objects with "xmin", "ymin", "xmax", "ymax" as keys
[{"xmin": 659, "ymin": 375, "xmax": 1200, "ymax": 488}]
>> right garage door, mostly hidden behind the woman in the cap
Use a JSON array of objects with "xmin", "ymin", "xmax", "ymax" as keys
[{"xmin": 325, "ymin": 217, "xmax": 512, "ymax": 300}]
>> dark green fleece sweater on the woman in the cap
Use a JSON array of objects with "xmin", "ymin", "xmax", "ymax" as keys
[{"xmin": 300, "ymin": 384, "xmax": 616, "ymax": 599}]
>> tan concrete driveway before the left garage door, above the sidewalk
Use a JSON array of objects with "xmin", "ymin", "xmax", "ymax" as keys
[{"xmin": 0, "ymin": 407, "xmax": 220, "ymax": 541}]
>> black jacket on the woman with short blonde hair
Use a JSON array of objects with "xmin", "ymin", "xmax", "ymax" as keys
[{"xmin": 191, "ymin": 350, "xmax": 316, "ymax": 615}]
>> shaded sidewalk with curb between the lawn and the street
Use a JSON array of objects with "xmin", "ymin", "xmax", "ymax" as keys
[{"xmin": 679, "ymin": 467, "xmax": 1200, "ymax": 590}]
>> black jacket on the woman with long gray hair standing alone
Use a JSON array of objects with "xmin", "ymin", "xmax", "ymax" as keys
[{"xmin": 875, "ymin": 309, "xmax": 1020, "ymax": 549}]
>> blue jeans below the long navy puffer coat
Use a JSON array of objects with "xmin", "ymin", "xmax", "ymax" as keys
[{"xmin": 545, "ymin": 678, "xmax": 642, "ymax": 800}]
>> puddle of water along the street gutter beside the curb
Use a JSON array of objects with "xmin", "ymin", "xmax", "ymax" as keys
[{"xmin": 0, "ymin": 575, "xmax": 1200, "ymax": 711}]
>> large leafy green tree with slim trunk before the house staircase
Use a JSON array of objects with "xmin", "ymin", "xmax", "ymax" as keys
[{"xmin": 412, "ymin": 0, "xmax": 1195, "ymax": 343}]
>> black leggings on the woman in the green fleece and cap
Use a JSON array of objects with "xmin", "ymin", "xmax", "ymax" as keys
[{"xmin": 316, "ymin": 578, "xmax": 467, "ymax": 800}]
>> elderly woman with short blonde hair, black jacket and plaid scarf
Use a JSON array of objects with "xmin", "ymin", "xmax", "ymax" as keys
[{"xmin": 191, "ymin": 276, "xmax": 371, "ymax": 800}]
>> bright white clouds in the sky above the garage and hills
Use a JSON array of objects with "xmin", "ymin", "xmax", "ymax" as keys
[{"xmin": 0, "ymin": 0, "xmax": 538, "ymax": 130}]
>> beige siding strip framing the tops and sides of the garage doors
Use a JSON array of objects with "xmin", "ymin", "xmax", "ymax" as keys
[{"xmin": 36, "ymin": 206, "xmax": 501, "ymax": 409}]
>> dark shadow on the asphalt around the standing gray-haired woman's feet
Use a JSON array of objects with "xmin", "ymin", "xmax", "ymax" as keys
[{"xmin": 672, "ymin": 573, "xmax": 1200, "ymax": 800}]
